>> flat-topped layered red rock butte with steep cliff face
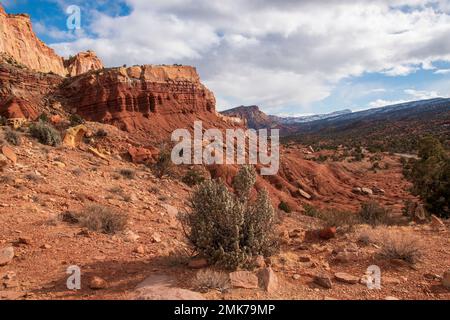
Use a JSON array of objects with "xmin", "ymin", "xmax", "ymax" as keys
[{"xmin": 60, "ymin": 65, "xmax": 221, "ymax": 136}]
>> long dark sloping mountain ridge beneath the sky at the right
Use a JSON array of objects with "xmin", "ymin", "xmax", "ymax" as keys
[{"xmin": 285, "ymin": 98, "xmax": 450, "ymax": 153}]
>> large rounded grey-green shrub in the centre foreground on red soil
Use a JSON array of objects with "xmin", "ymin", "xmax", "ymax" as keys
[{"xmin": 181, "ymin": 167, "xmax": 276, "ymax": 269}]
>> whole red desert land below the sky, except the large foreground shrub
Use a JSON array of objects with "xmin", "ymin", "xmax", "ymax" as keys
[{"xmin": 0, "ymin": 6, "xmax": 450, "ymax": 300}]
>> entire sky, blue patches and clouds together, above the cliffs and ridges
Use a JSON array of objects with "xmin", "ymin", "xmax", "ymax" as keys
[{"xmin": 0, "ymin": 0, "xmax": 450, "ymax": 115}]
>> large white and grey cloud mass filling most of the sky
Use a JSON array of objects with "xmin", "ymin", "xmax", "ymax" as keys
[{"xmin": 53, "ymin": 0, "xmax": 450, "ymax": 113}]
